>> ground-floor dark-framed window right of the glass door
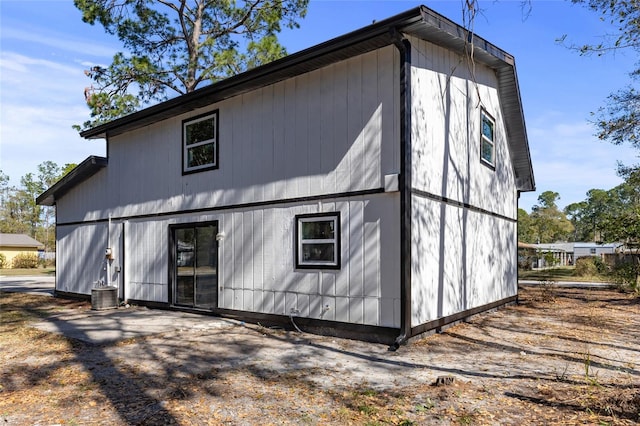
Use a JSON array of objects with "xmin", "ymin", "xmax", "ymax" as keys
[{"xmin": 296, "ymin": 213, "xmax": 340, "ymax": 269}]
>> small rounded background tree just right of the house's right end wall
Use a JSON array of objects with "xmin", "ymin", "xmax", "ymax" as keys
[{"xmin": 530, "ymin": 191, "xmax": 573, "ymax": 243}]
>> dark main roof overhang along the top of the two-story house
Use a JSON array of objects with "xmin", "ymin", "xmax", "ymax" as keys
[{"xmin": 61, "ymin": 6, "xmax": 535, "ymax": 202}]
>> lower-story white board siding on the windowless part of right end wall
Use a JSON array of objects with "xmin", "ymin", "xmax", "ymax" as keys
[{"xmin": 411, "ymin": 196, "xmax": 517, "ymax": 327}]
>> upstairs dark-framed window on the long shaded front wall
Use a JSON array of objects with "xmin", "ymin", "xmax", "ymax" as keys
[{"xmin": 182, "ymin": 111, "xmax": 218, "ymax": 174}]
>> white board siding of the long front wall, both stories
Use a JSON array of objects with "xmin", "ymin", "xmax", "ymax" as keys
[{"xmin": 58, "ymin": 46, "xmax": 401, "ymax": 327}]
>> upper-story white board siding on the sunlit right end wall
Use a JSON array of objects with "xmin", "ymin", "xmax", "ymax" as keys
[{"xmin": 411, "ymin": 35, "xmax": 517, "ymax": 218}]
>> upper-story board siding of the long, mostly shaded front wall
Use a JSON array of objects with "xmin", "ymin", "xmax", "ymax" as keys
[{"xmin": 58, "ymin": 46, "xmax": 399, "ymax": 223}]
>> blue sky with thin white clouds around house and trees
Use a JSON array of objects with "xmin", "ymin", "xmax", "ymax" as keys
[{"xmin": 0, "ymin": 0, "xmax": 637, "ymax": 211}]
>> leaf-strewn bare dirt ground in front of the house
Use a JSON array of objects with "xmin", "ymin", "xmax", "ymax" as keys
[{"xmin": 0, "ymin": 286, "xmax": 640, "ymax": 425}]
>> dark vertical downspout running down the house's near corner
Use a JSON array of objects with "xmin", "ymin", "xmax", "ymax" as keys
[{"xmin": 390, "ymin": 28, "xmax": 412, "ymax": 350}]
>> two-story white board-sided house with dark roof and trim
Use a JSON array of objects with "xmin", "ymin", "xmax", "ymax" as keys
[{"xmin": 37, "ymin": 6, "xmax": 535, "ymax": 345}]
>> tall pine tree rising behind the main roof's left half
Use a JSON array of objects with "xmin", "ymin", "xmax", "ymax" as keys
[{"xmin": 74, "ymin": 0, "xmax": 309, "ymax": 130}]
